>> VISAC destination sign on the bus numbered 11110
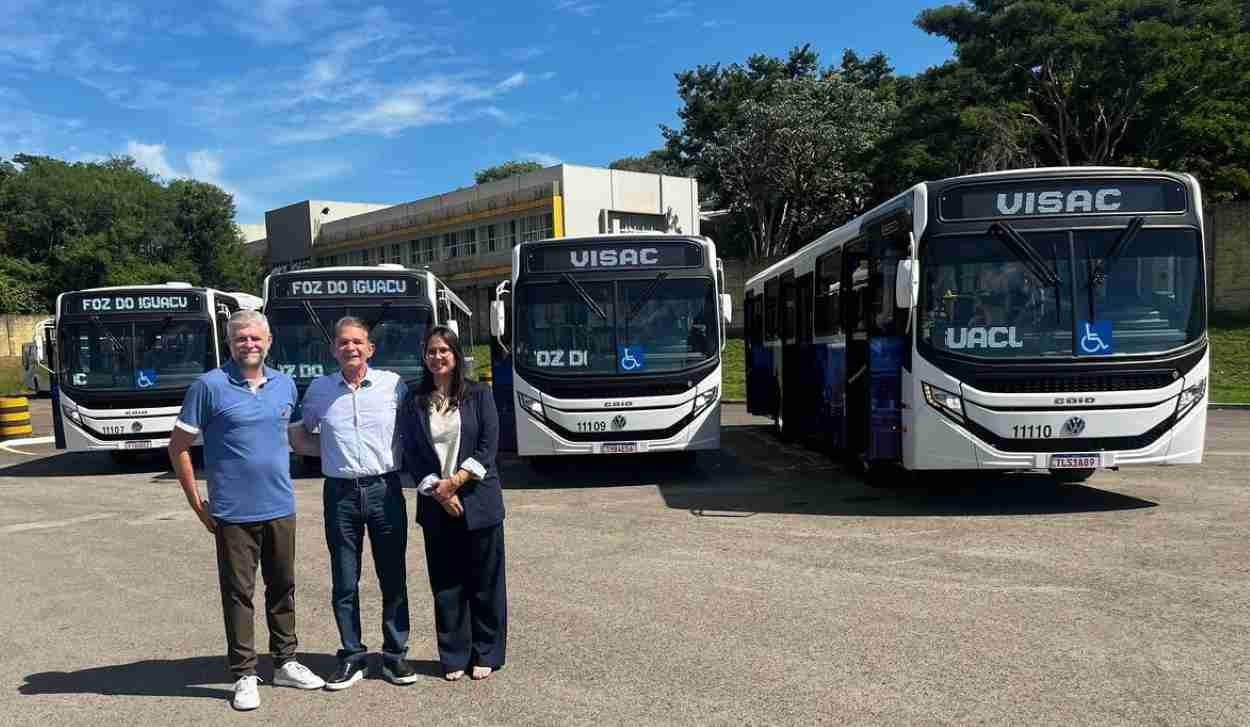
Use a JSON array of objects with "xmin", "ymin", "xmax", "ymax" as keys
[{"xmin": 939, "ymin": 179, "xmax": 1186, "ymax": 221}]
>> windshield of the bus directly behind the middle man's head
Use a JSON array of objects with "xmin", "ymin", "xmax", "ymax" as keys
[{"xmin": 268, "ymin": 304, "xmax": 433, "ymax": 385}]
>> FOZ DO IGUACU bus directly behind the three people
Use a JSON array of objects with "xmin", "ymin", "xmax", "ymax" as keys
[{"xmin": 265, "ymin": 265, "xmax": 473, "ymax": 396}]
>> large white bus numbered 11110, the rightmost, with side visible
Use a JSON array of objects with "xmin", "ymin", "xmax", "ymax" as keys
[{"xmin": 745, "ymin": 167, "xmax": 1209, "ymax": 481}]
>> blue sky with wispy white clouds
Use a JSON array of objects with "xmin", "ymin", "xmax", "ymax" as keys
[{"xmin": 0, "ymin": 0, "xmax": 951, "ymax": 222}]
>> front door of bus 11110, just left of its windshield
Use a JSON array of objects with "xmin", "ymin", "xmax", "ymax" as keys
[{"xmin": 864, "ymin": 209, "xmax": 911, "ymax": 462}]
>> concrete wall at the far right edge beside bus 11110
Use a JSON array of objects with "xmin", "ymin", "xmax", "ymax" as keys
[{"xmin": 1205, "ymin": 202, "xmax": 1250, "ymax": 315}]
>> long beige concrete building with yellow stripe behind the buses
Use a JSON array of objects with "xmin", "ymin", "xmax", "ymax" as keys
[{"xmin": 254, "ymin": 164, "xmax": 699, "ymax": 336}]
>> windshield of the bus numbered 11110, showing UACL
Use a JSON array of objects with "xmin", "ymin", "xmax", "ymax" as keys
[{"xmin": 919, "ymin": 229, "xmax": 1205, "ymax": 359}]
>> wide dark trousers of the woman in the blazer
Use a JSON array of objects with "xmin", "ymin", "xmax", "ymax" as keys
[{"xmin": 425, "ymin": 517, "xmax": 508, "ymax": 672}]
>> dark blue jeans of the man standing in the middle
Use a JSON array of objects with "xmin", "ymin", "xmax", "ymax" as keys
[{"xmin": 325, "ymin": 473, "xmax": 409, "ymax": 661}]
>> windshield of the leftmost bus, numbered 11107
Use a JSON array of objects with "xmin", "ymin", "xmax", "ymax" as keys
[{"xmin": 60, "ymin": 316, "xmax": 216, "ymax": 391}]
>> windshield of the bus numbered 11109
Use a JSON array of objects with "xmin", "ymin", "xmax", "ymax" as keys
[{"xmin": 515, "ymin": 274, "xmax": 719, "ymax": 375}]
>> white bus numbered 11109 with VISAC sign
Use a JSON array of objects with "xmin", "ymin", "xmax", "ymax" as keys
[{"xmin": 491, "ymin": 234, "xmax": 733, "ymax": 456}]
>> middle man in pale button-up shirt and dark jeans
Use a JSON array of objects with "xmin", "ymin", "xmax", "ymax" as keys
[{"xmin": 290, "ymin": 316, "xmax": 416, "ymax": 690}]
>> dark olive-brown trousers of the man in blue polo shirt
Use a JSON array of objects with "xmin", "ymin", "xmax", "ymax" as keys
[{"xmin": 215, "ymin": 515, "xmax": 299, "ymax": 678}]
